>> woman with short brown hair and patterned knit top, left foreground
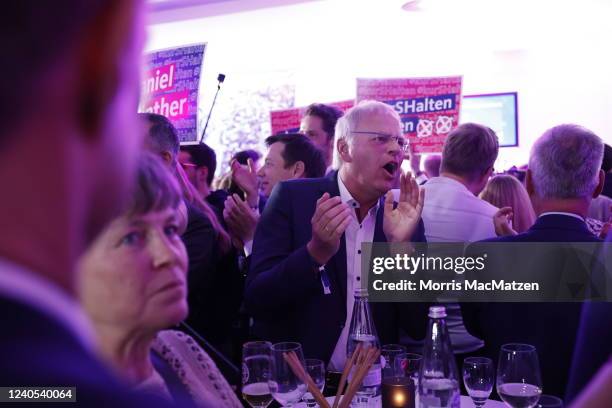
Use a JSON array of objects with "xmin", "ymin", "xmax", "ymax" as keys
[{"xmin": 79, "ymin": 154, "xmax": 242, "ymax": 407}]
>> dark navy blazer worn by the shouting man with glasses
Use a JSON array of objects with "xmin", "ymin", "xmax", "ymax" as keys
[{"xmin": 245, "ymin": 172, "xmax": 427, "ymax": 361}]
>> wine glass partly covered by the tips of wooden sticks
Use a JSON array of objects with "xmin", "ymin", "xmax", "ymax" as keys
[{"xmin": 268, "ymin": 342, "xmax": 306, "ymax": 407}]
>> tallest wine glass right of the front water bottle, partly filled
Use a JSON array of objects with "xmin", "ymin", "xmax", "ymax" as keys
[{"xmin": 497, "ymin": 343, "xmax": 542, "ymax": 408}]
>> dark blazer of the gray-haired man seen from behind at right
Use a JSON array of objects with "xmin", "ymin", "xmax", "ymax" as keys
[{"xmin": 462, "ymin": 215, "xmax": 601, "ymax": 398}]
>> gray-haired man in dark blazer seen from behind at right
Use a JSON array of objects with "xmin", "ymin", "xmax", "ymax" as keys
[{"xmin": 464, "ymin": 125, "xmax": 605, "ymax": 396}]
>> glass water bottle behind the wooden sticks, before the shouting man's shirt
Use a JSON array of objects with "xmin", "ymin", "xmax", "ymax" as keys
[{"xmin": 346, "ymin": 289, "xmax": 382, "ymax": 407}]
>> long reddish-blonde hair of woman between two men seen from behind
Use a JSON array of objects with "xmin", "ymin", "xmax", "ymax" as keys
[{"xmin": 480, "ymin": 174, "xmax": 536, "ymax": 233}]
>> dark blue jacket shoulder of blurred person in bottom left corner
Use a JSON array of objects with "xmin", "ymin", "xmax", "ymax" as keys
[{"xmin": 0, "ymin": 297, "xmax": 179, "ymax": 407}]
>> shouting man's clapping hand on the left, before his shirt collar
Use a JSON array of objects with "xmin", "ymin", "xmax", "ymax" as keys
[{"xmin": 306, "ymin": 193, "xmax": 354, "ymax": 265}]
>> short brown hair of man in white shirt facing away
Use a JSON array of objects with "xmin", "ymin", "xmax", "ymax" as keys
[{"xmin": 440, "ymin": 123, "xmax": 499, "ymax": 179}]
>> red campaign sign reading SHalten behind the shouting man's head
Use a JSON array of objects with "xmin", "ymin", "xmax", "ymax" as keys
[{"xmin": 357, "ymin": 77, "xmax": 462, "ymax": 153}]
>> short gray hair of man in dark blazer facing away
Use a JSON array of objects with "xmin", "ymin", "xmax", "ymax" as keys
[{"xmin": 529, "ymin": 124, "xmax": 604, "ymax": 198}]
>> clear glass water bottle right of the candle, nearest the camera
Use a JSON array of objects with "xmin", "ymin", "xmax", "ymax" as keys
[{"xmin": 418, "ymin": 306, "xmax": 460, "ymax": 408}]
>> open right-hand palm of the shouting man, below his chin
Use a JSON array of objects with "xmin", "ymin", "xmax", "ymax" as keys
[{"xmin": 383, "ymin": 173, "xmax": 425, "ymax": 242}]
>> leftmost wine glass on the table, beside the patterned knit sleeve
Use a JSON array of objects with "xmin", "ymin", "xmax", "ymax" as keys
[{"xmin": 242, "ymin": 341, "xmax": 272, "ymax": 408}]
